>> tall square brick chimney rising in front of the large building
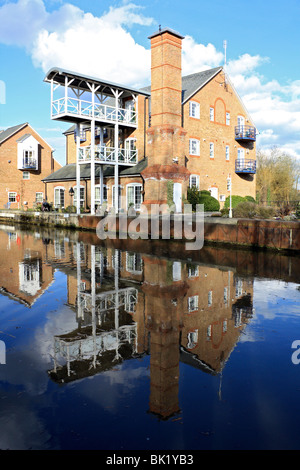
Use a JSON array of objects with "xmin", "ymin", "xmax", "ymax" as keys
[{"xmin": 142, "ymin": 28, "xmax": 189, "ymax": 211}]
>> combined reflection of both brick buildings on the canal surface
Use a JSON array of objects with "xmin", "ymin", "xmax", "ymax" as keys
[{"xmin": 0, "ymin": 226, "xmax": 298, "ymax": 450}]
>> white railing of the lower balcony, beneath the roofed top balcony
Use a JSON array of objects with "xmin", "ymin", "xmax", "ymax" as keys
[{"xmin": 79, "ymin": 145, "xmax": 138, "ymax": 165}]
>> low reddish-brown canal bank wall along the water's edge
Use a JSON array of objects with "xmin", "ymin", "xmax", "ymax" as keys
[{"xmin": 0, "ymin": 210, "xmax": 300, "ymax": 253}]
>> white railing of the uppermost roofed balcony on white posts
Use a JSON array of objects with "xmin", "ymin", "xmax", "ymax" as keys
[{"xmin": 51, "ymin": 98, "xmax": 137, "ymax": 125}]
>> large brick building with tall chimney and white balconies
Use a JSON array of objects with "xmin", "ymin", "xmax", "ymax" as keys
[{"xmin": 44, "ymin": 29, "xmax": 256, "ymax": 213}]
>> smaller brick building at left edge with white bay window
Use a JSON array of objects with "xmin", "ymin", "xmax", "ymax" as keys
[{"xmin": 0, "ymin": 123, "xmax": 61, "ymax": 209}]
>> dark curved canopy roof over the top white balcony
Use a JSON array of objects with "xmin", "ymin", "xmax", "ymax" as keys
[{"xmin": 44, "ymin": 67, "xmax": 149, "ymax": 96}]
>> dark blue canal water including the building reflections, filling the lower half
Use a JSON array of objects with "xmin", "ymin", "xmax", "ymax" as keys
[{"xmin": 0, "ymin": 225, "xmax": 300, "ymax": 451}]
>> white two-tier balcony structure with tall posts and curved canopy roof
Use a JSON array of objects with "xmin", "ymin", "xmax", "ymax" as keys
[{"xmin": 44, "ymin": 68, "xmax": 149, "ymax": 215}]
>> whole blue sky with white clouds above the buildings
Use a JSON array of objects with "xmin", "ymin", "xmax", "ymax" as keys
[{"xmin": 0, "ymin": 0, "xmax": 300, "ymax": 164}]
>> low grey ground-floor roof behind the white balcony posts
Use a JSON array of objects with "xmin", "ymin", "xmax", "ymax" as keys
[{"xmin": 42, "ymin": 158, "xmax": 148, "ymax": 183}]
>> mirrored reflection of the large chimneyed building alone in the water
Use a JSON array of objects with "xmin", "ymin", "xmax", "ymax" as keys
[{"xmin": 48, "ymin": 242, "xmax": 253, "ymax": 419}]
